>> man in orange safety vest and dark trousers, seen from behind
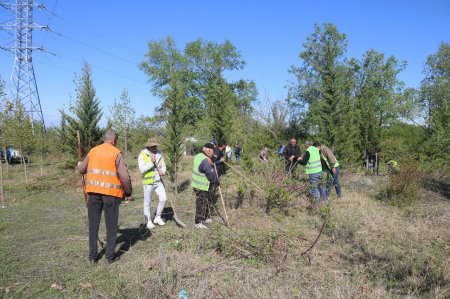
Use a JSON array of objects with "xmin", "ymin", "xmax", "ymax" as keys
[{"xmin": 78, "ymin": 129, "xmax": 132, "ymax": 264}]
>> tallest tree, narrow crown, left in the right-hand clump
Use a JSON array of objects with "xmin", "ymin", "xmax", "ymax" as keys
[{"xmin": 288, "ymin": 23, "xmax": 353, "ymax": 156}]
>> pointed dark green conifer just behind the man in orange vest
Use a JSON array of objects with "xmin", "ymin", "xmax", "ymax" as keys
[{"xmin": 58, "ymin": 63, "xmax": 103, "ymax": 157}]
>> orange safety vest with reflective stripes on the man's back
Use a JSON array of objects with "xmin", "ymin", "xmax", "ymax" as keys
[{"xmin": 86, "ymin": 143, "xmax": 123, "ymax": 198}]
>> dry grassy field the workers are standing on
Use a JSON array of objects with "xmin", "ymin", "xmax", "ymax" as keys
[{"xmin": 0, "ymin": 160, "xmax": 450, "ymax": 298}]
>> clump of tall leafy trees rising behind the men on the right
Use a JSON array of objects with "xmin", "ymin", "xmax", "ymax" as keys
[{"xmin": 288, "ymin": 23, "xmax": 414, "ymax": 162}]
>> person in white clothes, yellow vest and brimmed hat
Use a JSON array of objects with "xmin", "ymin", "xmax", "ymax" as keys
[{"xmin": 138, "ymin": 138, "xmax": 167, "ymax": 229}]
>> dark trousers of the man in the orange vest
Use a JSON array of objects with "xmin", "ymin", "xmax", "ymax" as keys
[{"xmin": 88, "ymin": 193, "xmax": 121, "ymax": 260}]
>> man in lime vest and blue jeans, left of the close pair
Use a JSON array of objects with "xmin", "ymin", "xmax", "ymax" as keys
[{"xmin": 297, "ymin": 141, "xmax": 327, "ymax": 204}]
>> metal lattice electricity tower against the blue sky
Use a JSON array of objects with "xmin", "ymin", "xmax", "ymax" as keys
[{"xmin": 0, "ymin": 0, "xmax": 48, "ymax": 127}]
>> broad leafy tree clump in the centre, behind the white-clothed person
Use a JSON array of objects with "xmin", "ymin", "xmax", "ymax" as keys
[{"xmin": 140, "ymin": 37, "xmax": 257, "ymax": 157}]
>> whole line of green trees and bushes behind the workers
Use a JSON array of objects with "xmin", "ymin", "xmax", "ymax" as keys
[{"xmin": 0, "ymin": 23, "xmax": 450, "ymax": 181}]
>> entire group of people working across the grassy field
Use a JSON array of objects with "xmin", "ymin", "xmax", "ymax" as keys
[{"xmin": 78, "ymin": 129, "xmax": 342, "ymax": 264}]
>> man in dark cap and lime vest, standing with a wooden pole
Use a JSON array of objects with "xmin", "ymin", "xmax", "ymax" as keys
[{"xmin": 191, "ymin": 143, "xmax": 219, "ymax": 228}]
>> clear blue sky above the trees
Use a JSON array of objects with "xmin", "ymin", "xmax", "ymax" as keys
[{"xmin": 0, "ymin": 0, "xmax": 450, "ymax": 126}]
